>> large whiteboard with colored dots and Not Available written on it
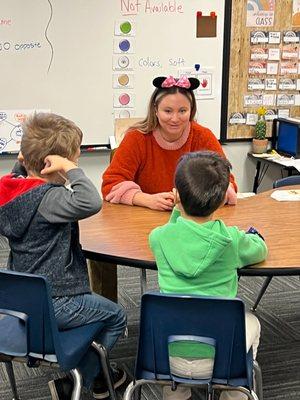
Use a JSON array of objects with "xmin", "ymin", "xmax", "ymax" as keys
[{"xmin": 0, "ymin": 0, "xmax": 230, "ymax": 151}]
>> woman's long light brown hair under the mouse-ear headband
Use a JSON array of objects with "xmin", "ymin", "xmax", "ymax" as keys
[{"xmin": 127, "ymin": 86, "xmax": 197, "ymax": 133}]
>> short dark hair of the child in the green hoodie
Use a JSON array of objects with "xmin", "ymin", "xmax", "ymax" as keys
[{"xmin": 175, "ymin": 151, "xmax": 231, "ymax": 217}]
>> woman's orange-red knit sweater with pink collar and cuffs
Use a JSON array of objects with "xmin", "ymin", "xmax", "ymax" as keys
[{"xmin": 102, "ymin": 122, "xmax": 237, "ymax": 203}]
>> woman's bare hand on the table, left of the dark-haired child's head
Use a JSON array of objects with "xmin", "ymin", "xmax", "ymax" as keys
[{"xmin": 133, "ymin": 192, "xmax": 174, "ymax": 211}]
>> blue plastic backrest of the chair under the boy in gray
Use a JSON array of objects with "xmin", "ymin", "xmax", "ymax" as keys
[{"xmin": 0, "ymin": 269, "xmax": 61, "ymax": 361}]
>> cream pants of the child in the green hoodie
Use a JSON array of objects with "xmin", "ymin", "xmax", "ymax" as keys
[{"xmin": 163, "ymin": 312, "xmax": 260, "ymax": 400}]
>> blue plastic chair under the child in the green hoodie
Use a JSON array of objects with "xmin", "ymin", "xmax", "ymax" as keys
[{"xmin": 123, "ymin": 292, "xmax": 262, "ymax": 400}]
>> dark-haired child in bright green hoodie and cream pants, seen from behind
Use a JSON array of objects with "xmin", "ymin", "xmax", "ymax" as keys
[{"xmin": 149, "ymin": 151, "xmax": 267, "ymax": 400}]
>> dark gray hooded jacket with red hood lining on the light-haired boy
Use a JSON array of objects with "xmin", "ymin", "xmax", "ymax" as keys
[{"xmin": 0, "ymin": 168, "xmax": 101, "ymax": 297}]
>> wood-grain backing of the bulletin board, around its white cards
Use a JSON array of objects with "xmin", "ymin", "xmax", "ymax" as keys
[{"xmin": 227, "ymin": 0, "xmax": 300, "ymax": 139}]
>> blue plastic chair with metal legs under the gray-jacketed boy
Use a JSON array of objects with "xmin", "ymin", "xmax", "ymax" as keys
[{"xmin": 0, "ymin": 270, "xmax": 116, "ymax": 400}]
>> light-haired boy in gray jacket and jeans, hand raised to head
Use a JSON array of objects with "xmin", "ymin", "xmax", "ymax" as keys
[{"xmin": 0, "ymin": 113, "xmax": 126, "ymax": 400}]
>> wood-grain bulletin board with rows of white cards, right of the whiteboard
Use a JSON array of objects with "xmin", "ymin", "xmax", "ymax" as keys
[{"xmin": 226, "ymin": 0, "xmax": 300, "ymax": 141}]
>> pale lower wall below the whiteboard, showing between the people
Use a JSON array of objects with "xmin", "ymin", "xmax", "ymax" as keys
[{"xmin": 0, "ymin": 143, "xmax": 280, "ymax": 192}]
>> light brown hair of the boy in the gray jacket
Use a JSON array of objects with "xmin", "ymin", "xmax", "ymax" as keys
[{"xmin": 20, "ymin": 113, "xmax": 83, "ymax": 176}]
